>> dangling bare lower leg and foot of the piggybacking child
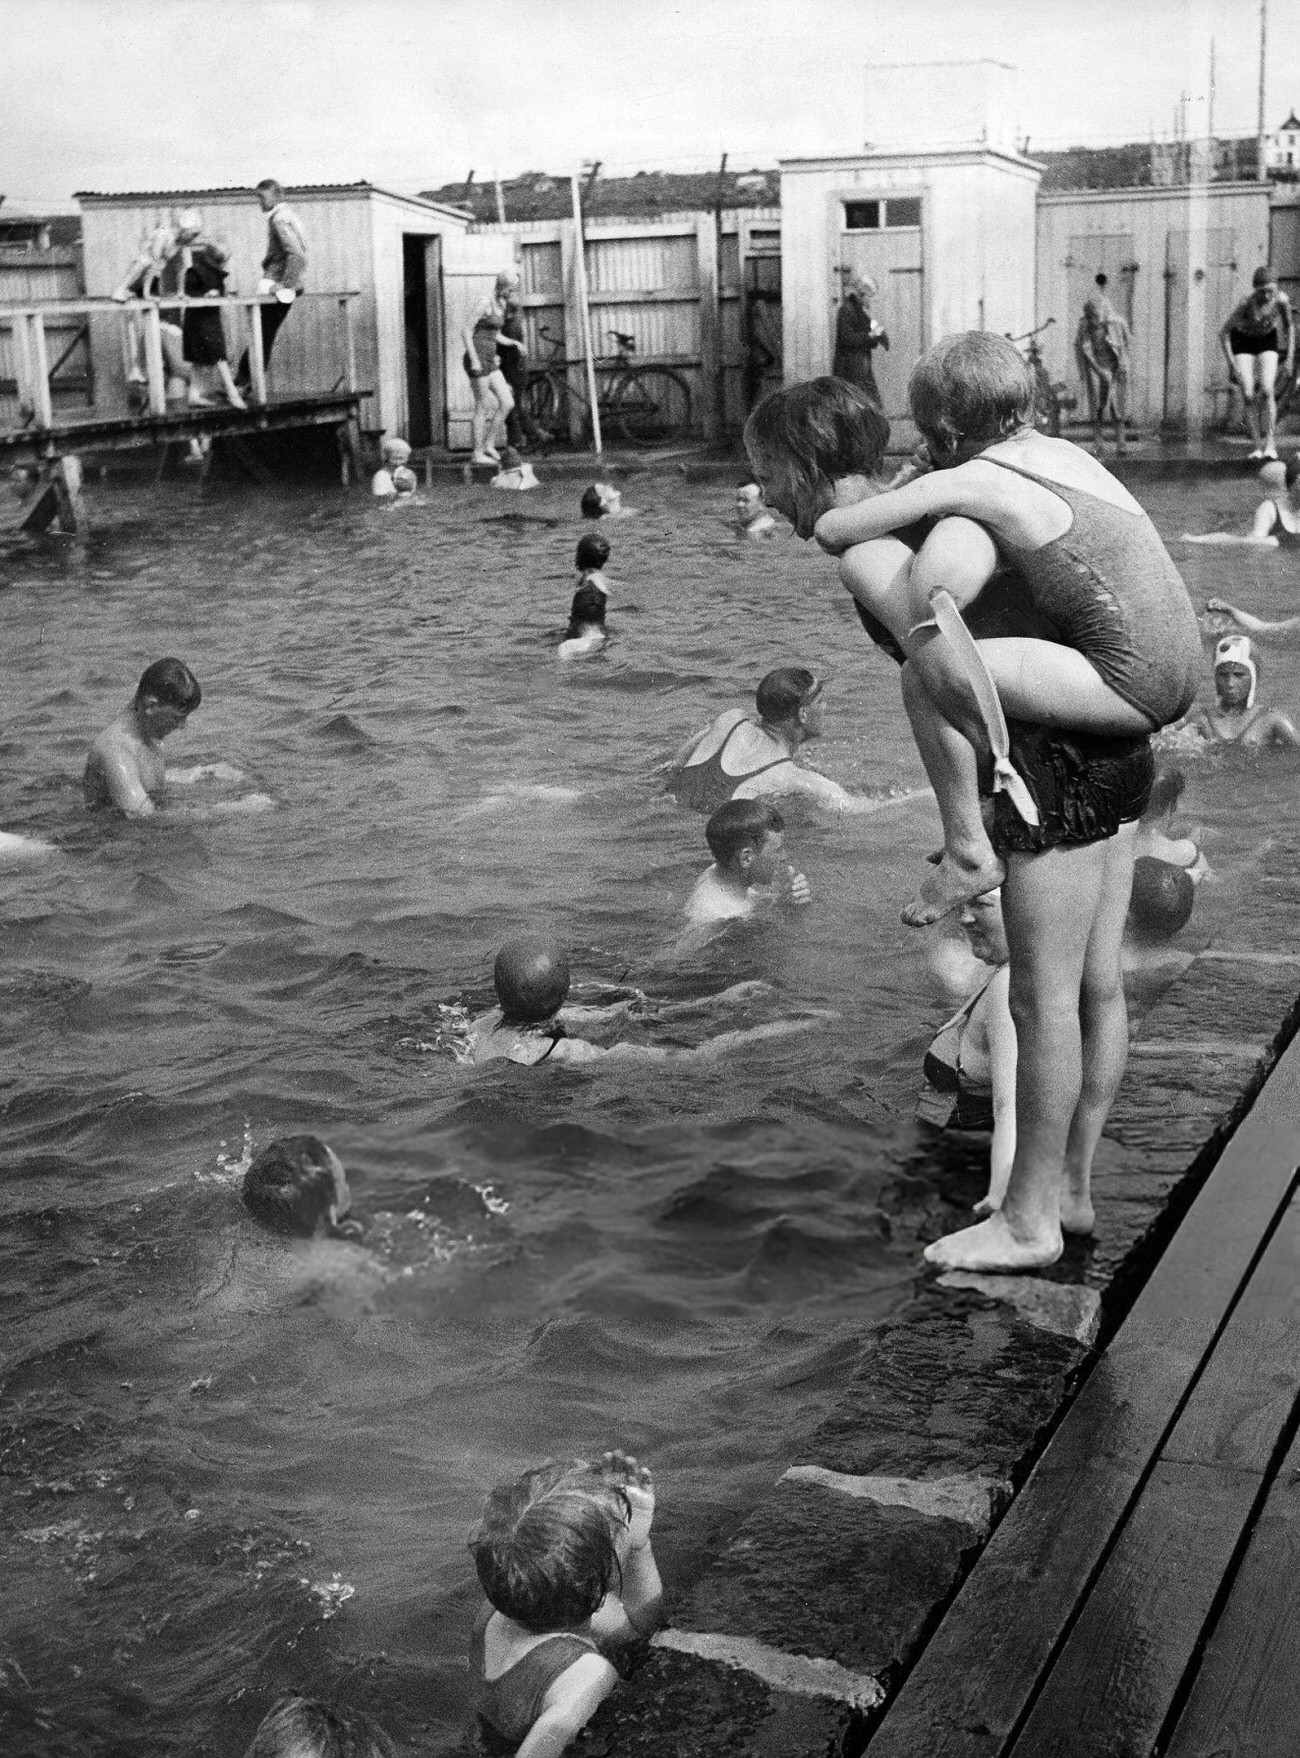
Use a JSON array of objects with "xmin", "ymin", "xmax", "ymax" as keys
[{"xmin": 901, "ymin": 663, "xmax": 1006, "ymax": 928}]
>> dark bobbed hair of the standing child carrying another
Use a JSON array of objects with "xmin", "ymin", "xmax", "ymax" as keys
[{"xmin": 744, "ymin": 378, "xmax": 888, "ymax": 536}]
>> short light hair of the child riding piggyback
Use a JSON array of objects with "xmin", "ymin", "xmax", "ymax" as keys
[{"xmin": 908, "ymin": 331, "xmax": 1034, "ymax": 462}]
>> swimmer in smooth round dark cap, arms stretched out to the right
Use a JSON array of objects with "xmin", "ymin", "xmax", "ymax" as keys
[{"xmin": 468, "ymin": 933, "xmax": 823, "ymax": 1067}]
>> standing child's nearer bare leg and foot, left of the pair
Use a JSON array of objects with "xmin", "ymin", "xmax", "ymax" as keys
[{"xmin": 925, "ymin": 842, "xmax": 1108, "ymax": 1271}]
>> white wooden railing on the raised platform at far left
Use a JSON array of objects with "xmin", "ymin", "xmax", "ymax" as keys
[{"xmin": 0, "ymin": 292, "xmax": 361, "ymax": 427}]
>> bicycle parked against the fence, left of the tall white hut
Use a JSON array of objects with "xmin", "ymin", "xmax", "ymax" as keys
[{"xmin": 522, "ymin": 325, "xmax": 691, "ymax": 447}]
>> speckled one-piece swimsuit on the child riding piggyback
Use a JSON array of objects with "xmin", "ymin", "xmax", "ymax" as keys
[{"xmin": 985, "ymin": 455, "xmax": 1201, "ymax": 731}]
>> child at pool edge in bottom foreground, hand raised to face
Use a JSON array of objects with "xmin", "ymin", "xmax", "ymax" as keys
[{"xmin": 470, "ymin": 1452, "xmax": 663, "ymax": 1758}]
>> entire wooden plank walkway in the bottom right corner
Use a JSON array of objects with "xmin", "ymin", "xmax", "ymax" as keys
[{"xmin": 865, "ymin": 1039, "xmax": 1300, "ymax": 1758}]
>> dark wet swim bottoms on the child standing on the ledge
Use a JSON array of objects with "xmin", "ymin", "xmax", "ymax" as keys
[{"xmin": 980, "ymin": 721, "xmax": 1156, "ymax": 854}]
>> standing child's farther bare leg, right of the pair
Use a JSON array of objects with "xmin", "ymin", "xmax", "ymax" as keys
[{"xmin": 1061, "ymin": 825, "xmax": 1136, "ymax": 1232}]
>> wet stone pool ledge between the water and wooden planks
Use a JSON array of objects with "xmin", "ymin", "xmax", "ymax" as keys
[{"xmin": 573, "ymin": 835, "xmax": 1300, "ymax": 1758}]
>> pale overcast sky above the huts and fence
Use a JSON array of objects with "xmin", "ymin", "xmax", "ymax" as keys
[{"xmin": 0, "ymin": 0, "xmax": 1300, "ymax": 206}]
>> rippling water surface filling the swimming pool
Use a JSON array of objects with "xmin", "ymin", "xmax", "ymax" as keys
[{"xmin": 0, "ymin": 460, "xmax": 1300, "ymax": 1758}]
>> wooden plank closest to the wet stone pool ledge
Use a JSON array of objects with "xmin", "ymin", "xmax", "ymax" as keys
[{"xmin": 867, "ymin": 1041, "xmax": 1300, "ymax": 1758}]
